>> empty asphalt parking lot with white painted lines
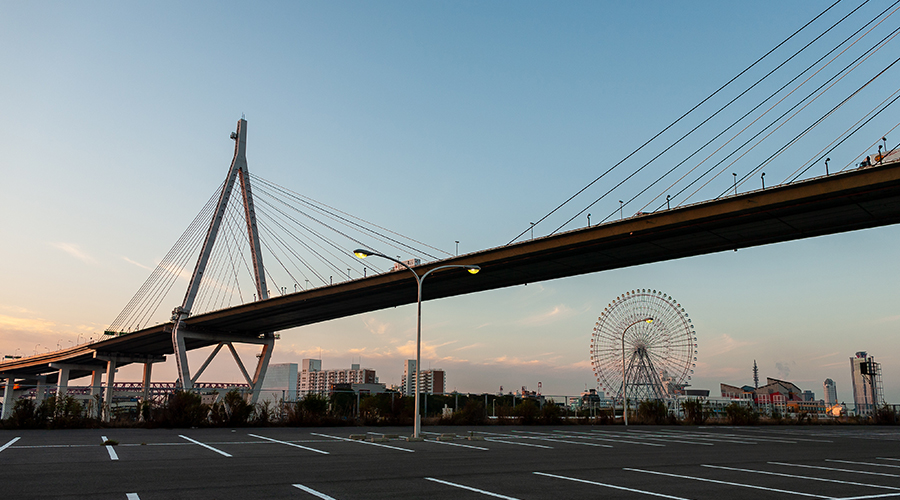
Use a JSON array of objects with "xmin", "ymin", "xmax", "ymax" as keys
[{"xmin": 0, "ymin": 426, "xmax": 900, "ymax": 500}]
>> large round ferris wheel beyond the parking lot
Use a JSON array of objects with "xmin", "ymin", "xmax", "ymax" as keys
[{"xmin": 591, "ymin": 289, "xmax": 697, "ymax": 400}]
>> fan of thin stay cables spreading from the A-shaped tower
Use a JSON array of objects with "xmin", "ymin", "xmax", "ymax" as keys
[{"xmin": 107, "ymin": 174, "xmax": 451, "ymax": 335}]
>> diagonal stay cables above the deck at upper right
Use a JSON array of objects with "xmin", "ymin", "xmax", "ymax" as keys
[{"xmin": 509, "ymin": 0, "xmax": 900, "ymax": 244}]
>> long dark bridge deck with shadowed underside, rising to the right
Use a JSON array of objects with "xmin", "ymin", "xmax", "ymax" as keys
[{"xmin": 0, "ymin": 163, "xmax": 900, "ymax": 378}]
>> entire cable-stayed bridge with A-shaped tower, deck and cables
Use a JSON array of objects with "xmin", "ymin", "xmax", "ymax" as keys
[{"xmin": 0, "ymin": 0, "xmax": 900, "ymax": 416}]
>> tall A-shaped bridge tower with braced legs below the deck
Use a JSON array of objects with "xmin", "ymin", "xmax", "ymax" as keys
[{"xmin": 172, "ymin": 117, "xmax": 275, "ymax": 403}]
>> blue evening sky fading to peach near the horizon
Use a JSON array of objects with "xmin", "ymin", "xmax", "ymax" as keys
[{"xmin": 0, "ymin": 1, "xmax": 900, "ymax": 403}]
